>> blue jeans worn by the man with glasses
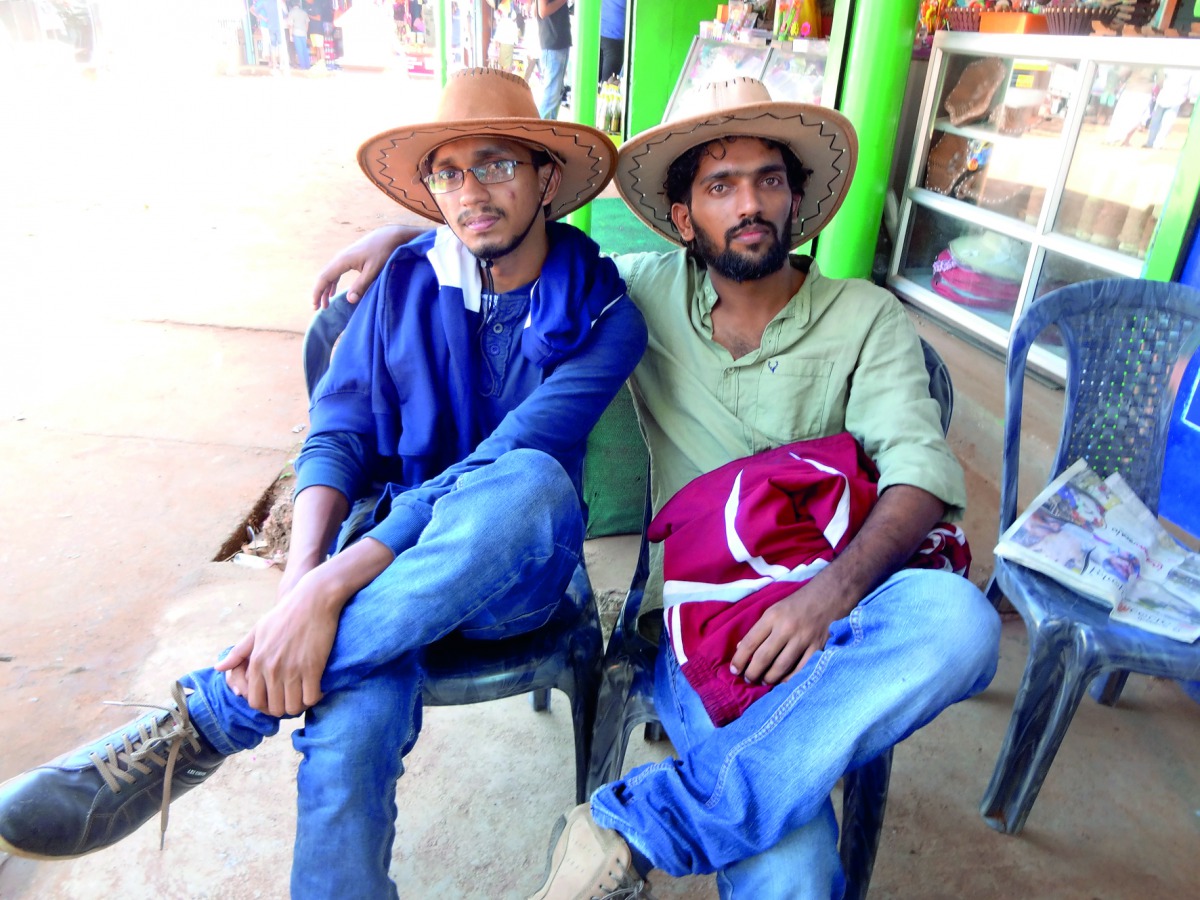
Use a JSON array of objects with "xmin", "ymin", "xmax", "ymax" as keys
[{"xmin": 180, "ymin": 450, "xmax": 583, "ymax": 899}]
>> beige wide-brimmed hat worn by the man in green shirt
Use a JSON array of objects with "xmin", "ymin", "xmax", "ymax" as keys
[{"xmin": 617, "ymin": 78, "xmax": 858, "ymax": 250}]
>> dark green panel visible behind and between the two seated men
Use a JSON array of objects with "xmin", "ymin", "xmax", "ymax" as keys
[{"xmin": 583, "ymin": 198, "xmax": 674, "ymax": 538}]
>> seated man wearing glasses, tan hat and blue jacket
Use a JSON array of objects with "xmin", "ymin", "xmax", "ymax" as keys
[{"xmin": 0, "ymin": 68, "xmax": 646, "ymax": 899}]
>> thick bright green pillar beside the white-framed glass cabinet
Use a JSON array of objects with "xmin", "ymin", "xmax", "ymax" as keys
[{"xmin": 816, "ymin": 0, "xmax": 919, "ymax": 278}]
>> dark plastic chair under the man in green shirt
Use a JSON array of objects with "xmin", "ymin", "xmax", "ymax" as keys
[{"xmin": 588, "ymin": 340, "xmax": 954, "ymax": 900}]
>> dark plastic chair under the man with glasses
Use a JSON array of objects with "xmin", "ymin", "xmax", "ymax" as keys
[{"xmin": 304, "ymin": 294, "xmax": 604, "ymax": 803}]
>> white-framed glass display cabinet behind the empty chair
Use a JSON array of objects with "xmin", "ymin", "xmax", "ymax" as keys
[{"xmin": 888, "ymin": 32, "xmax": 1200, "ymax": 378}]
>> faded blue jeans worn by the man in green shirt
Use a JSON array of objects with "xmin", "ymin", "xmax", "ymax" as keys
[{"xmin": 592, "ymin": 570, "xmax": 1000, "ymax": 900}]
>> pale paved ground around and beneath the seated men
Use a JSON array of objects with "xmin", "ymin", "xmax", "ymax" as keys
[{"xmin": 0, "ymin": 60, "xmax": 1200, "ymax": 900}]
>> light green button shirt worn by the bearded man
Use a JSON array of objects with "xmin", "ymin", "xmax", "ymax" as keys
[{"xmin": 614, "ymin": 250, "xmax": 966, "ymax": 612}]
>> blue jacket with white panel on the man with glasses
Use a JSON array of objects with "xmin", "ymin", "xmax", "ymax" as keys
[{"xmin": 296, "ymin": 222, "xmax": 646, "ymax": 554}]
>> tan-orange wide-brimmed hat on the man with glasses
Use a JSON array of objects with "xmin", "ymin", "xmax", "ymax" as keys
[{"xmin": 359, "ymin": 68, "xmax": 617, "ymax": 222}]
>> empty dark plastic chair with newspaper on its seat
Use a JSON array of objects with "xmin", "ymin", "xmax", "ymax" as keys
[{"xmin": 980, "ymin": 278, "xmax": 1200, "ymax": 834}]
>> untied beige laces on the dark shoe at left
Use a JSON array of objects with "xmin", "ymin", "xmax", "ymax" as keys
[{"xmin": 88, "ymin": 682, "xmax": 200, "ymax": 850}]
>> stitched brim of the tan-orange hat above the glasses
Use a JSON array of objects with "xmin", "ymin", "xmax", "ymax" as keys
[{"xmin": 359, "ymin": 118, "xmax": 617, "ymax": 222}]
